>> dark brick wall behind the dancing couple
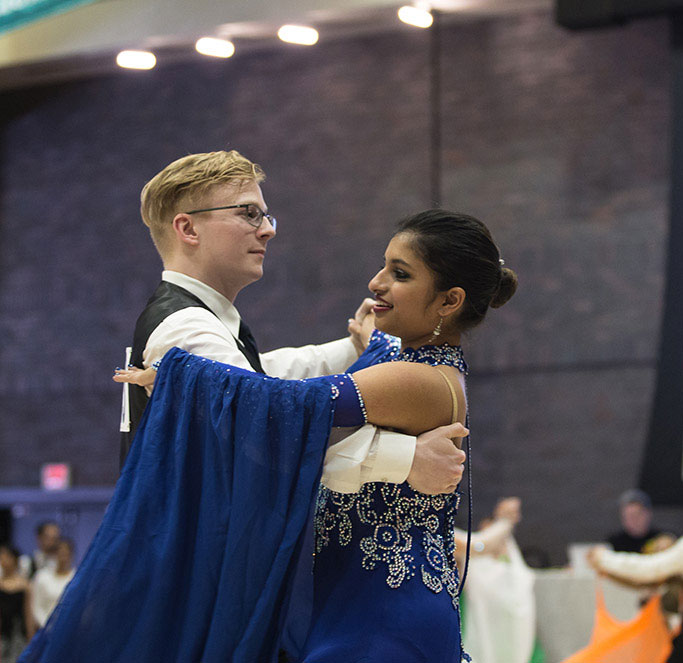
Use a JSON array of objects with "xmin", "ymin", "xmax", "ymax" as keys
[{"xmin": 0, "ymin": 13, "xmax": 680, "ymax": 559}]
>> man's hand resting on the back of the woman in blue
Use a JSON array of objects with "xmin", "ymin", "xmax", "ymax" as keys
[{"xmin": 408, "ymin": 424, "xmax": 469, "ymax": 495}]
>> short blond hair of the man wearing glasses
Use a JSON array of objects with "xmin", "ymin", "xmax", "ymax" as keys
[{"xmin": 140, "ymin": 150, "xmax": 266, "ymax": 255}]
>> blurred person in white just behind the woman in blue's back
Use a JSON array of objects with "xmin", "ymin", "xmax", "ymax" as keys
[{"xmin": 455, "ymin": 497, "xmax": 536, "ymax": 663}]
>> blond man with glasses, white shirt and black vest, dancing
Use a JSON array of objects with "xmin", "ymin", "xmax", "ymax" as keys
[{"xmin": 121, "ymin": 150, "xmax": 465, "ymax": 494}]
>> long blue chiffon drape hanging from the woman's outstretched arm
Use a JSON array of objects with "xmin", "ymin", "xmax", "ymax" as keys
[{"xmin": 19, "ymin": 348, "xmax": 333, "ymax": 663}]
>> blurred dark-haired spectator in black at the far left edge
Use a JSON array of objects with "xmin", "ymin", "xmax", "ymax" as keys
[{"xmin": 0, "ymin": 545, "xmax": 30, "ymax": 663}]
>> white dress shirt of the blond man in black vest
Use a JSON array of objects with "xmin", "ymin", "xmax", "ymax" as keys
[{"xmin": 138, "ymin": 270, "xmax": 415, "ymax": 493}]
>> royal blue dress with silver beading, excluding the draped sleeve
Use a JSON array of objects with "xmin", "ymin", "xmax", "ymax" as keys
[{"xmin": 302, "ymin": 332, "xmax": 469, "ymax": 663}]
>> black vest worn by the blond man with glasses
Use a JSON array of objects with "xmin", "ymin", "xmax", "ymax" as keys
[{"xmin": 119, "ymin": 281, "xmax": 216, "ymax": 467}]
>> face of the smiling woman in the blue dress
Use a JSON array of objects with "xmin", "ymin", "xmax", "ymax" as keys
[{"xmin": 368, "ymin": 233, "xmax": 443, "ymax": 348}]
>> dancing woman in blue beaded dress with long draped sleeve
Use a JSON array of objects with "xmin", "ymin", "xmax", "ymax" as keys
[{"xmin": 23, "ymin": 210, "xmax": 516, "ymax": 663}]
